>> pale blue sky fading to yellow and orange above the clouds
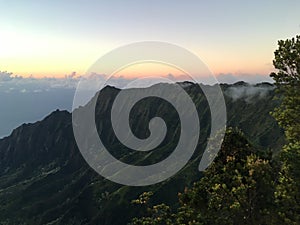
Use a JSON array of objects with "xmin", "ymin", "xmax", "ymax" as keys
[{"xmin": 0, "ymin": 0, "xmax": 300, "ymax": 79}]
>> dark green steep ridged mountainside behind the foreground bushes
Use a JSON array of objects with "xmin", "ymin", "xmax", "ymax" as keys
[{"xmin": 0, "ymin": 83, "xmax": 283, "ymax": 225}]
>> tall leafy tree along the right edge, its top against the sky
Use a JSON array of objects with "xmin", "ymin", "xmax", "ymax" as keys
[{"xmin": 270, "ymin": 36, "xmax": 300, "ymax": 224}]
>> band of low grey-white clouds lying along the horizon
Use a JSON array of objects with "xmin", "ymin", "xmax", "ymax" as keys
[{"xmin": 0, "ymin": 71, "xmax": 273, "ymax": 93}]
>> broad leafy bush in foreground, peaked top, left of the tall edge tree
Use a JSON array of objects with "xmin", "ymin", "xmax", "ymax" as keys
[{"xmin": 132, "ymin": 129, "xmax": 275, "ymax": 225}]
